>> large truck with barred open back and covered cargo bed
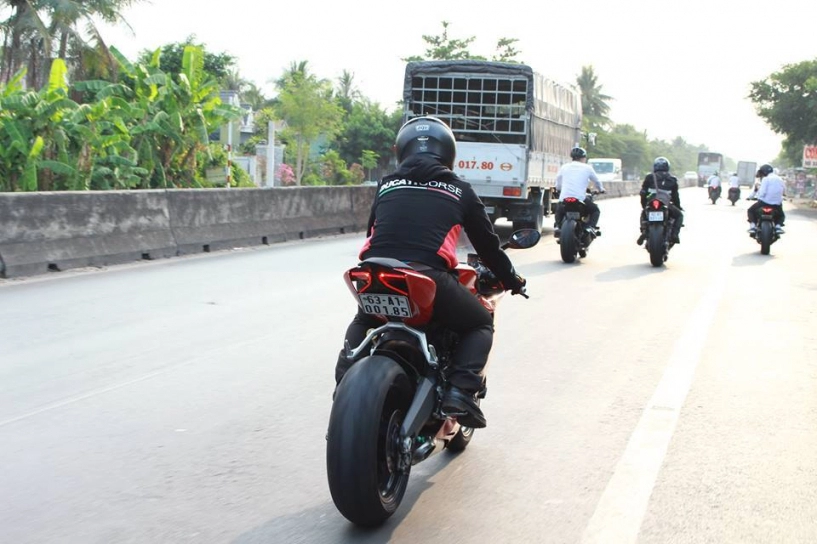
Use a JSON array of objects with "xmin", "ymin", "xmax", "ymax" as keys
[{"xmin": 403, "ymin": 60, "xmax": 582, "ymax": 230}]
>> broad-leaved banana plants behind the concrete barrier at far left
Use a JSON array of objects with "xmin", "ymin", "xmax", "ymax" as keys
[{"xmin": 0, "ymin": 47, "xmax": 241, "ymax": 191}]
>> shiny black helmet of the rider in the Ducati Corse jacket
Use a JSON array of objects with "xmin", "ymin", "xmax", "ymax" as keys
[{"xmin": 394, "ymin": 116, "xmax": 457, "ymax": 168}]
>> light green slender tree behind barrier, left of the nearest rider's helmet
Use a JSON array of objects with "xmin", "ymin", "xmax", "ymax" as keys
[{"xmin": 276, "ymin": 62, "xmax": 343, "ymax": 185}]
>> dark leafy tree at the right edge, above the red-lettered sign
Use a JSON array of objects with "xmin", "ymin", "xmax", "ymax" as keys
[{"xmin": 749, "ymin": 59, "xmax": 817, "ymax": 164}]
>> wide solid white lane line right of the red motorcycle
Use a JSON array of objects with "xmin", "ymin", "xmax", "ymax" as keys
[{"xmin": 582, "ymin": 272, "xmax": 726, "ymax": 544}]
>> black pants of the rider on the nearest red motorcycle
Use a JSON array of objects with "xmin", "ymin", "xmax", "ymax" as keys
[{"xmin": 335, "ymin": 269, "xmax": 494, "ymax": 393}]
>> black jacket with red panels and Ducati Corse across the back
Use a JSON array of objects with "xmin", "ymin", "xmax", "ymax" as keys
[{"xmin": 360, "ymin": 154, "xmax": 518, "ymax": 289}]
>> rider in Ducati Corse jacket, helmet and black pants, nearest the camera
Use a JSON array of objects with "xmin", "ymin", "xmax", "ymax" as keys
[{"xmin": 335, "ymin": 116, "xmax": 525, "ymax": 428}]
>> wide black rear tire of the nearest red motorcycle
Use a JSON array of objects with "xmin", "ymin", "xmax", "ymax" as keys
[{"xmin": 326, "ymin": 355, "xmax": 413, "ymax": 527}]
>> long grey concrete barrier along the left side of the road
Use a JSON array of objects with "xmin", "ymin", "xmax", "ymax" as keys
[{"xmin": 0, "ymin": 180, "xmax": 694, "ymax": 278}]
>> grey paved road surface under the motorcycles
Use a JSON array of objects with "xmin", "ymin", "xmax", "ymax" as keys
[{"xmin": 0, "ymin": 188, "xmax": 817, "ymax": 544}]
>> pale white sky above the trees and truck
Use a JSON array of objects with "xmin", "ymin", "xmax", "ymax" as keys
[{"xmin": 99, "ymin": 0, "xmax": 817, "ymax": 162}]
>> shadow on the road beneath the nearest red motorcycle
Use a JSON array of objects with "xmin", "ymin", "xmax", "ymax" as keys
[{"xmin": 232, "ymin": 452, "xmax": 457, "ymax": 544}]
